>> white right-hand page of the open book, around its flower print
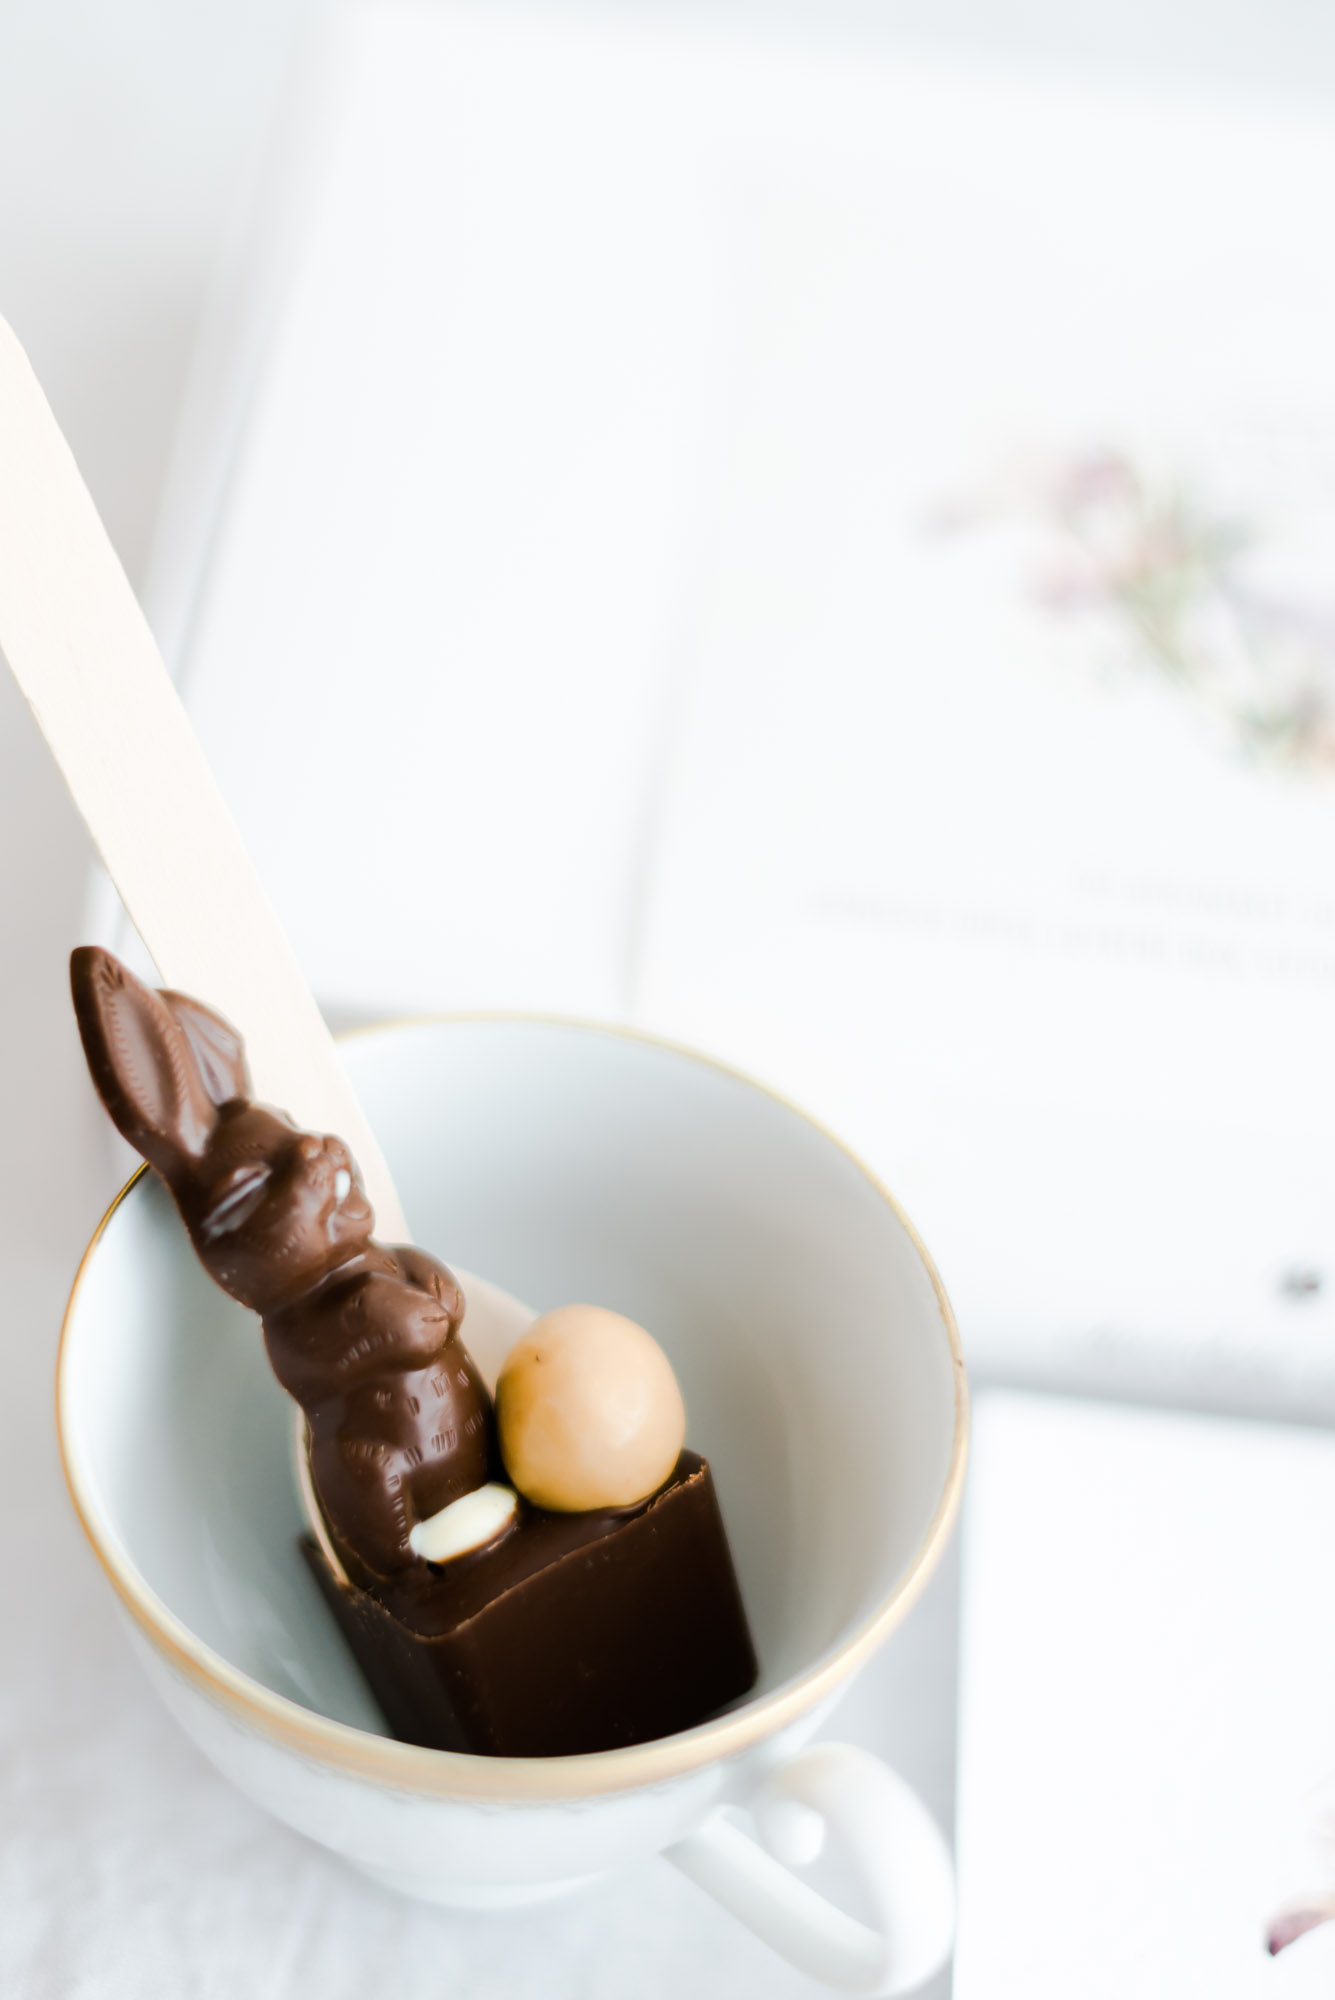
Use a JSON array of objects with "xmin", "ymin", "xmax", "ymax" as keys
[{"xmin": 640, "ymin": 68, "xmax": 1335, "ymax": 1414}]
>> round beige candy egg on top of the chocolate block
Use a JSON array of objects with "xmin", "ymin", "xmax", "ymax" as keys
[{"xmin": 496, "ymin": 1306, "xmax": 685, "ymax": 1514}]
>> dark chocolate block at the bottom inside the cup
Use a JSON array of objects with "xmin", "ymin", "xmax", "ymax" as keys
[{"xmin": 302, "ymin": 1452, "xmax": 755, "ymax": 1756}]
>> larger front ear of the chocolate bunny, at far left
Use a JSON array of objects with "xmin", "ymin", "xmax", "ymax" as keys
[{"xmin": 70, "ymin": 946, "xmax": 218, "ymax": 1180}]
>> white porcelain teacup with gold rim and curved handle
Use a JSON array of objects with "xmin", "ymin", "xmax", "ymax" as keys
[{"xmin": 58, "ymin": 1020, "xmax": 967, "ymax": 1994}]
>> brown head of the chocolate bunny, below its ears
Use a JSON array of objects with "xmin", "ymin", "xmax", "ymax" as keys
[{"xmin": 174, "ymin": 1102, "xmax": 376, "ymax": 1312}]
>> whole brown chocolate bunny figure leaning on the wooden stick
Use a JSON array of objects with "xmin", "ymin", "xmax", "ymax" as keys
[{"xmin": 70, "ymin": 946, "xmax": 500, "ymax": 1584}]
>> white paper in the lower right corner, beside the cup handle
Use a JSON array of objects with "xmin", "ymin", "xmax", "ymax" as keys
[{"xmin": 953, "ymin": 1394, "xmax": 1335, "ymax": 2000}]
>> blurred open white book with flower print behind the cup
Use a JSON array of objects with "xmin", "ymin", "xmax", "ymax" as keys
[{"xmin": 114, "ymin": 6, "xmax": 1335, "ymax": 1416}]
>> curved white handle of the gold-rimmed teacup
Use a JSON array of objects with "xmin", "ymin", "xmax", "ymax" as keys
[{"xmin": 664, "ymin": 1744, "xmax": 955, "ymax": 1994}]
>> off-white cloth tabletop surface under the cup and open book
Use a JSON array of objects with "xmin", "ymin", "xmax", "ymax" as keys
[{"xmin": 0, "ymin": 0, "xmax": 1335, "ymax": 2000}]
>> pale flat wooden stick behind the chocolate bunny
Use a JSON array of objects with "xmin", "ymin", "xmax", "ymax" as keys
[{"xmin": 0, "ymin": 320, "xmax": 410, "ymax": 1242}]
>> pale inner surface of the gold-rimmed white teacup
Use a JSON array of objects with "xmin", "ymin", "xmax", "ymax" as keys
[{"xmin": 60, "ymin": 1020, "xmax": 965, "ymax": 1790}]
